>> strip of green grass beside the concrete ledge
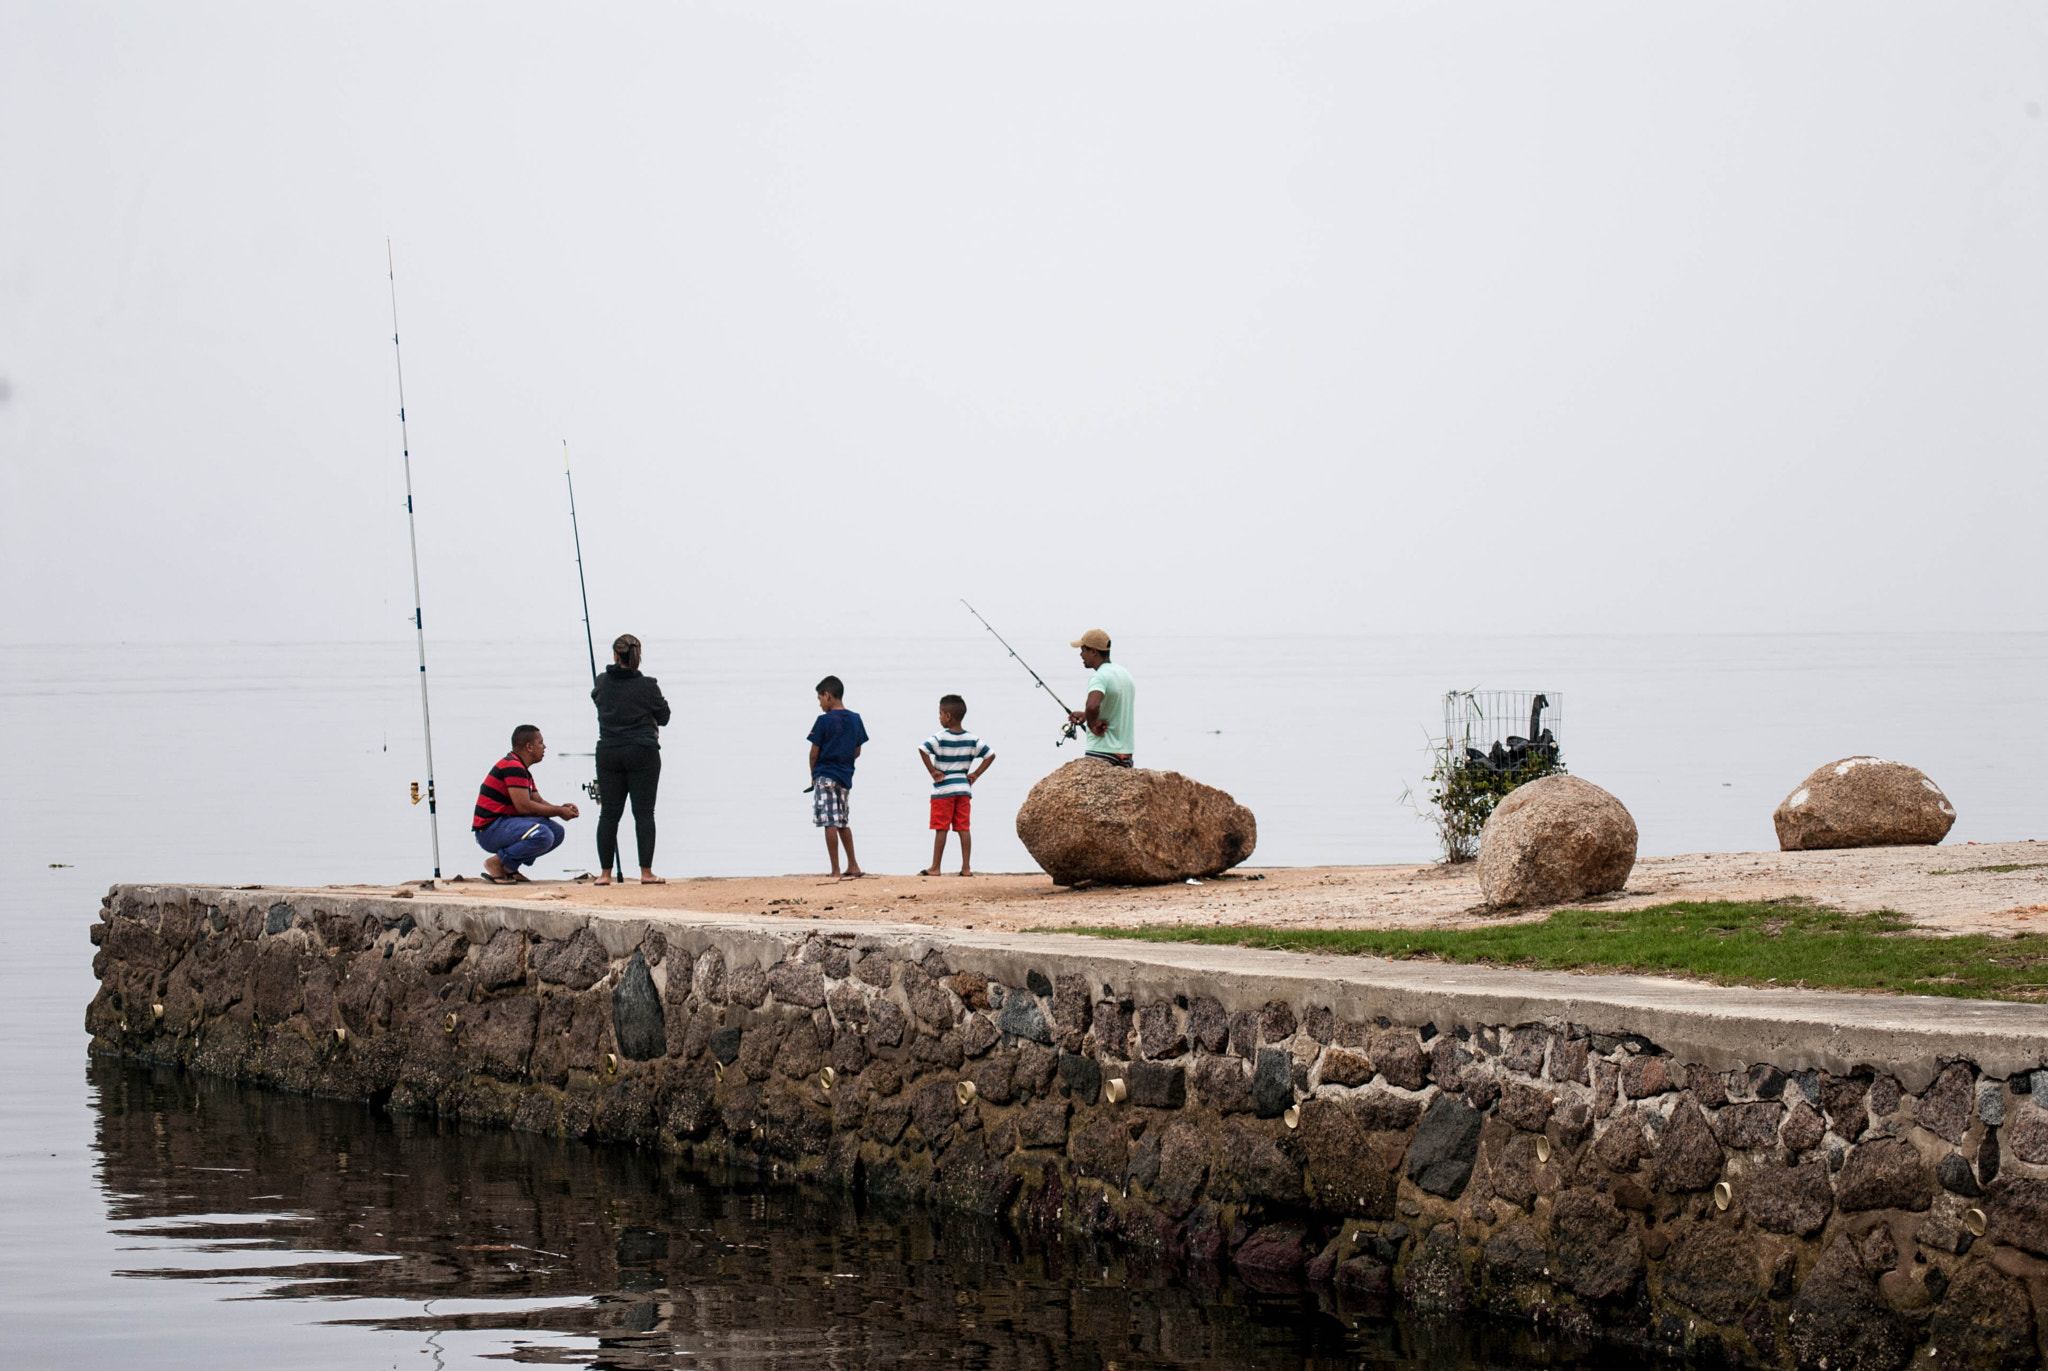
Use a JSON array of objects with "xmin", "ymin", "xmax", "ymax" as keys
[{"xmin": 1061, "ymin": 900, "xmax": 2048, "ymax": 1000}]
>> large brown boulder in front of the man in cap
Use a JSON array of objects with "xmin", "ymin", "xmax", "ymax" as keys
[{"xmin": 1018, "ymin": 758, "xmax": 1260, "ymax": 885}]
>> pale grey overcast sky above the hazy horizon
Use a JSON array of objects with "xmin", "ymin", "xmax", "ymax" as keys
[{"xmin": 0, "ymin": 0, "xmax": 2048, "ymax": 641}]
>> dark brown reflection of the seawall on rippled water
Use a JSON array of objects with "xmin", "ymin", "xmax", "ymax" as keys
[{"xmin": 92, "ymin": 1062, "xmax": 1640, "ymax": 1371}]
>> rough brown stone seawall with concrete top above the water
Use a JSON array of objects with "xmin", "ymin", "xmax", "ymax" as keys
[{"xmin": 86, "ymin": 885, "xmax": 2048, "ymax": 1369}]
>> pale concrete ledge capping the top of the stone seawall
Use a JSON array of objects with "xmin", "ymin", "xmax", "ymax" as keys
[{"xmin": 121, "ymin": 885, "xmax": 2048, "ymax": 1092}]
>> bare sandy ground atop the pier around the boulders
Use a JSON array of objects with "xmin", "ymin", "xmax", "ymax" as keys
[{"xmin": 360, "ymin": 842, "xmax": 2048, "ymax": 934}]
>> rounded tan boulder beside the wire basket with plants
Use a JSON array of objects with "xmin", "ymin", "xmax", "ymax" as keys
[{"xmin": 1479, "ymin": 777, "xmax": 1636, "ymax": 908}]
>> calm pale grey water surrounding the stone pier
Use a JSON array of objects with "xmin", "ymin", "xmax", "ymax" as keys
[{"xmin": 0, "ymin": 635, "xmax": 2048, "ymax": 1367}]
